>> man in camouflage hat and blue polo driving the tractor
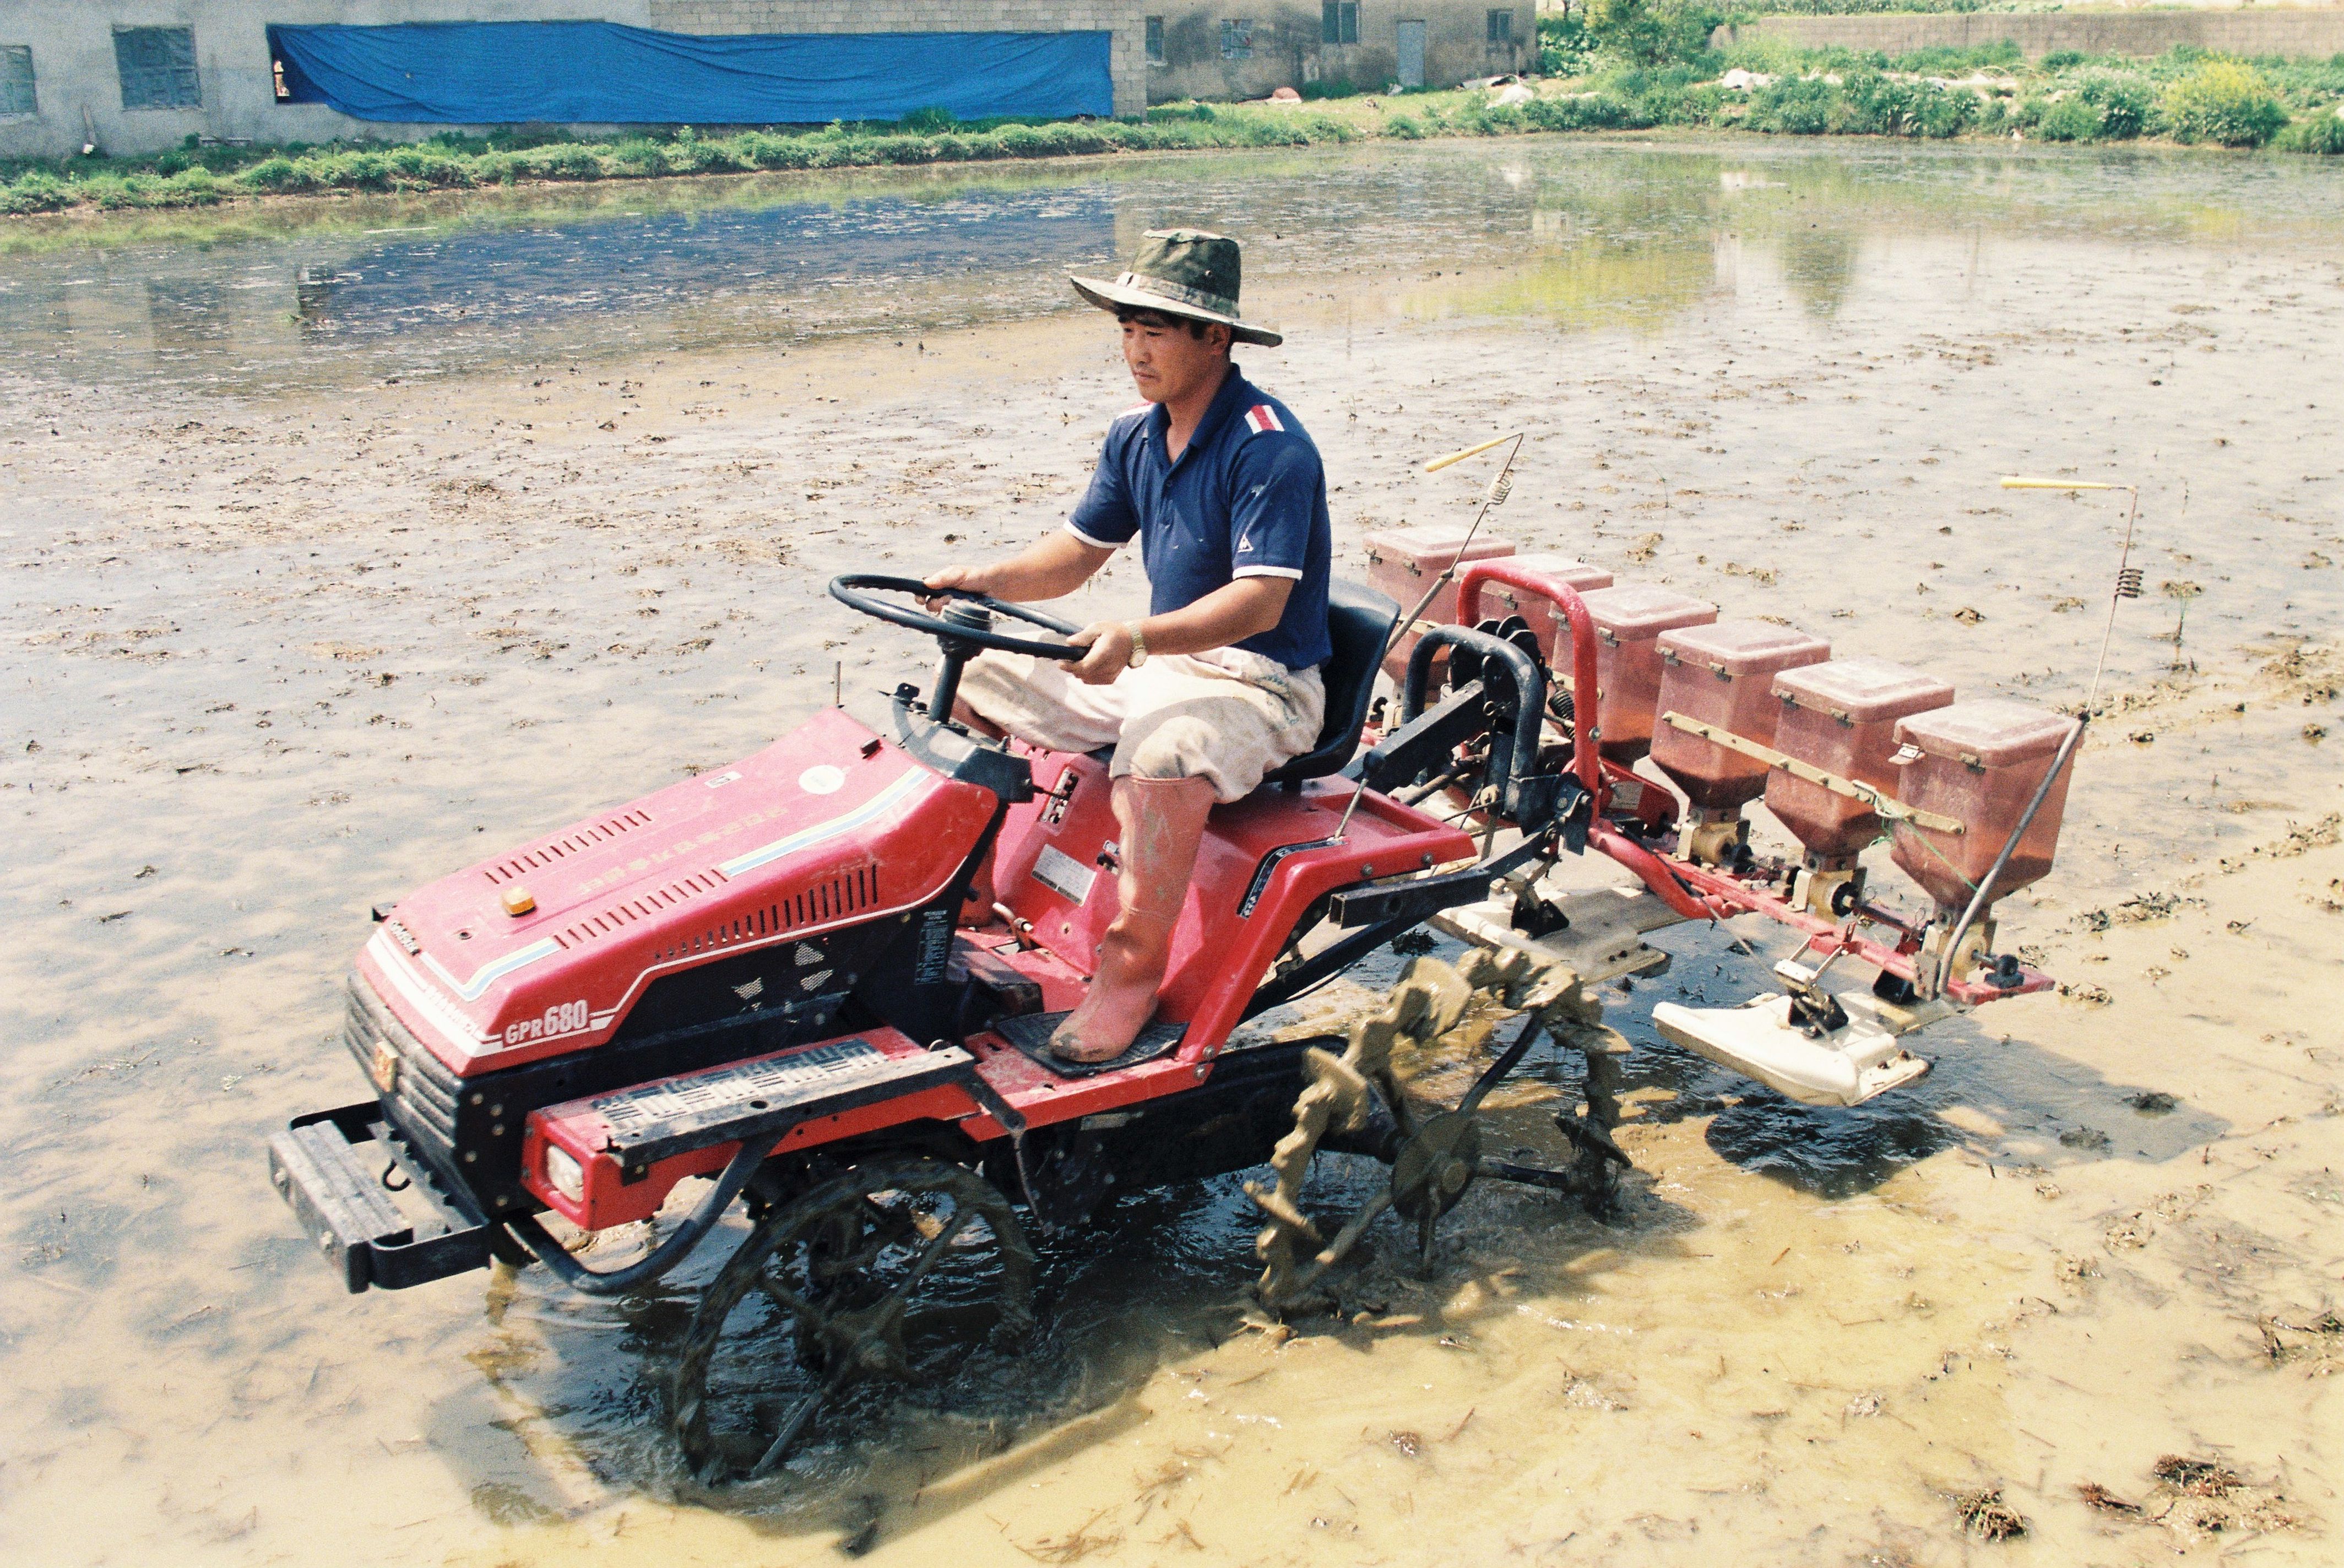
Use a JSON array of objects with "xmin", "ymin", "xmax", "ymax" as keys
[{"xmin": 926, "ymin": 230, "xmax": 1331, "ymax": 1062}]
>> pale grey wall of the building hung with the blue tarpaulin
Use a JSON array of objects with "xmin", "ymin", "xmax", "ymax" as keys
[{"xmin": 0, "ymin": 0, "xmax": 1146, "ymax": 157}]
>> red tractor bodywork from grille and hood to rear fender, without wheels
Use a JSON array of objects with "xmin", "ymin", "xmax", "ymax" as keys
[{"xmin": 333, "ymin": 689, "xmax": 1474, "ymax": 1256}]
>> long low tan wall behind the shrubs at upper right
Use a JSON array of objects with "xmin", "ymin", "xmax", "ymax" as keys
[{"xmin": 1711, "ymin": 5, "xmax": 2344, "ymax": 58}]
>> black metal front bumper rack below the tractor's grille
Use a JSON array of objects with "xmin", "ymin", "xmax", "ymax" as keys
[{"xmin": 269, "ymin": 1102, "xmax": 490, "ymax": 1296}]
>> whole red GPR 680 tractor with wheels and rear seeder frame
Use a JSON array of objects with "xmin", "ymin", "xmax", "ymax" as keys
[{"xmin": 269, "ymin": 560, "xmax": 2081, "ymax": 1474}]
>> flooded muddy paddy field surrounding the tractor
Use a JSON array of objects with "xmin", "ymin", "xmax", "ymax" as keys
[{"xmin": 0, "ymin": 140, "xmax": 2344, "ymax": 1563}]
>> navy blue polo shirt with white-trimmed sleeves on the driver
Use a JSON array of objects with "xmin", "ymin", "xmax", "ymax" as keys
[{"xmin": 1066, "ymin": 366, "xmax": 1334, "ymax": 670}]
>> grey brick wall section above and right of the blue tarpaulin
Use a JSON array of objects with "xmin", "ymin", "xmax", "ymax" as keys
[{"xmin": 649, "ymin": 0, "xmax": 1148, "ymax": 115}]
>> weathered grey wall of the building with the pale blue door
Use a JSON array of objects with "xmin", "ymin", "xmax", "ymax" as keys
[{"xmin": 1139, "ymin": 0, "xmax": 1538, "ymax": 103}]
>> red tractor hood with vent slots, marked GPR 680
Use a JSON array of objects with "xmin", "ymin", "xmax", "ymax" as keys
[{"xmin": 356, "ymin": 708, "xmax": 996, "ymax": 1076}]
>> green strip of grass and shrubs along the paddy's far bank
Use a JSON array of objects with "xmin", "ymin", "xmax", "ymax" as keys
[{"xmin": 0, "ymin": 35, "xmax": 2344, "ymax": 213}]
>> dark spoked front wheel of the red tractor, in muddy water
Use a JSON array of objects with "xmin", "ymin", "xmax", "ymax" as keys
[{"xmin": 670, "ymin": 1158, "xmax": 1034, "ymax": 1484}]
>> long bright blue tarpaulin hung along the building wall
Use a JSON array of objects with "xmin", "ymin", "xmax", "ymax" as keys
[{"xmin": 269, "ymin": 21, "xmax": 1116, "ymax": 124}]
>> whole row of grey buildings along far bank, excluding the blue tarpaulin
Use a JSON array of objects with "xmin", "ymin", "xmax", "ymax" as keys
[{"xmin": 0, "ymin": 0, "xmax": 1535, "ymax": 157}]
